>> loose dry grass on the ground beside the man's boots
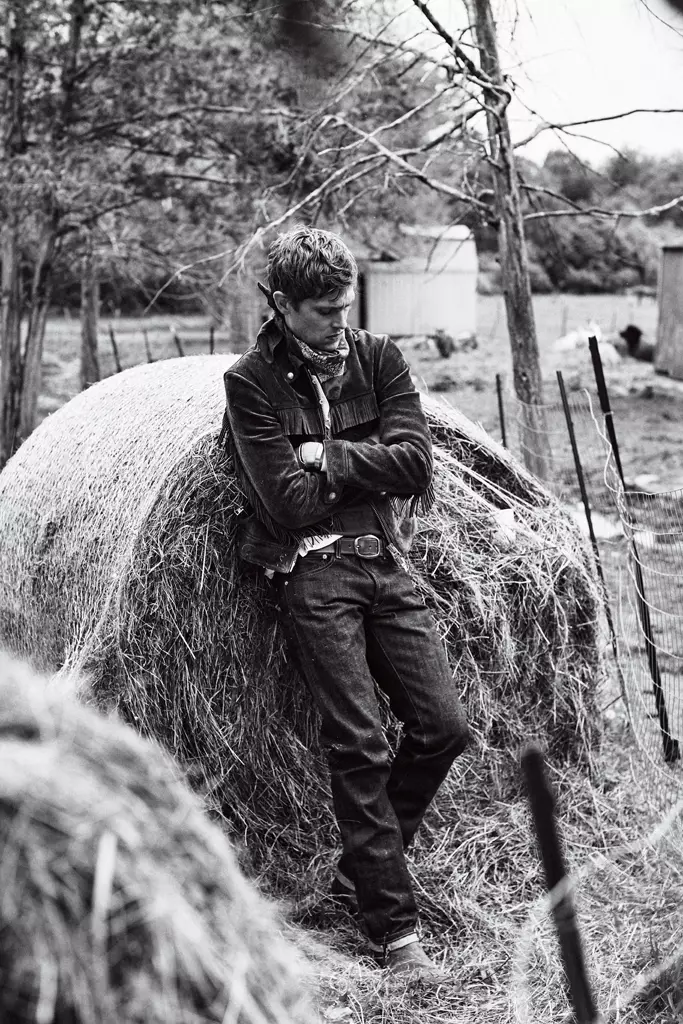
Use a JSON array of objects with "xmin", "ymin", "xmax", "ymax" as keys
[{"xmin": 307, "ymin": 723, "xmax": 683, "ymax": 1024}]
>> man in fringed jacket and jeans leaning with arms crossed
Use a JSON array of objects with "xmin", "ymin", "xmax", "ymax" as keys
[{"xmin": 225, "ymin": 227, "xmax": 468, "ymax": 974}]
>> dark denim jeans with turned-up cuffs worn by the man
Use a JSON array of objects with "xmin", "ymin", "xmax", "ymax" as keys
[{"xmin": 274, "ymin": 554, "xmax": 468, "ymax": 944}]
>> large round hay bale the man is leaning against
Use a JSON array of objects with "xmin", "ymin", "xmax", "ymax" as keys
[{"xmin": 0, "ymin": 355, "xmax": 603, "ymax": 884}]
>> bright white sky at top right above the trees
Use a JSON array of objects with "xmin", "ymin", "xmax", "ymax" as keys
[{"xmin": 401, "ymin": 0, "xmax": 683, "ymax": 165}]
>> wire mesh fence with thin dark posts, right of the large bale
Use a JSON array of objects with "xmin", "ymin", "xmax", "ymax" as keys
[{"xmin": 502, "ymin": 381, "xmax": 683, "ymax": 809}]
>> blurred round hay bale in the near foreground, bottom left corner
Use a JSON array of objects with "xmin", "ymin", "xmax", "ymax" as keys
[{"xmin": 0, "ymin": 655, "xmax": 312, "ymax": 1024}]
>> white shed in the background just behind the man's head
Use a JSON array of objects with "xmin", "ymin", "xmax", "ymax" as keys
[{"xmin": 354, "ymin": 225, "xmax": 477, "ymax": 337}]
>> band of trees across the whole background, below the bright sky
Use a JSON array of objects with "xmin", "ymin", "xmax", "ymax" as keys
[{"xmin": 0, "ymin": 0, "xmax": 683, "ymax": 465}]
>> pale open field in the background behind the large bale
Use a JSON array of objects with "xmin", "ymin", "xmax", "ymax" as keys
[{"xmin": 39, "ymin": 295, "xmax": 683, "ymax": 476}]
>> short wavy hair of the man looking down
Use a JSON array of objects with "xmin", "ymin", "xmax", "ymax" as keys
[{"xmin": 268, "ymin": 227, "xmax": 358, "ymax": 306}]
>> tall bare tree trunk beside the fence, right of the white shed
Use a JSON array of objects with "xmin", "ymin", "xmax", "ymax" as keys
[{"xmin": 472, "ymin": 0, "xmax": 551, "ymax": 479}]
